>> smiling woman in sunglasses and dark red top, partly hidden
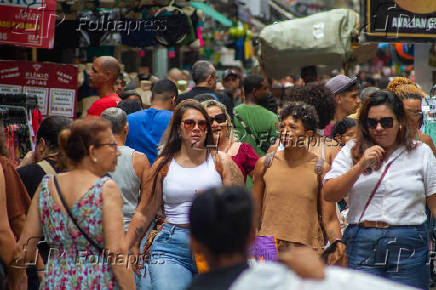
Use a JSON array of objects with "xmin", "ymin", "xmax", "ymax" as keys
[{"xmin": 202, "ymin": 100, "xmax": 259, "ymax": 181}]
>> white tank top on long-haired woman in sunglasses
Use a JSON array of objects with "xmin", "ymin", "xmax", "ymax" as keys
[{"xmin": 163, "ymin": 154, "xmax": 222, "ymax": 225}]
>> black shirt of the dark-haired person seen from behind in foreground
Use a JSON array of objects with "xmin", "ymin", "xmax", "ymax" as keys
[{"xmin": 188, "ymin": 263, "xmax": 248, "ymax": 290}]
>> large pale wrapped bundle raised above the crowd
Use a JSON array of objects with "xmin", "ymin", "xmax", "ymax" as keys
[{"xmin": 260, "ymin": 9, "xmax": 358, "ymax": 79}]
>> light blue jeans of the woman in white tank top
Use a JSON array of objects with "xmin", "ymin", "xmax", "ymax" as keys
[{"xmin": 149, "ymin": 224, "xmax": 197, "ymax": 290}]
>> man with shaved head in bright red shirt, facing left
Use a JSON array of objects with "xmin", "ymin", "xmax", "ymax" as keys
[{"xmin": 88, "ymin": 56, "xmax": 121, "ymax": 116}]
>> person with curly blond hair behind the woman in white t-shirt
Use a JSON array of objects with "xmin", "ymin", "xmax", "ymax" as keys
[{"xmin": 388, "ymin": 77, "xmax": 436, "ymax": 156}]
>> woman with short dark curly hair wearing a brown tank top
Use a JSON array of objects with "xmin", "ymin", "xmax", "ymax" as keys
[{"xmin": 252, "ymin": 102, "xmax": 343, "ymax": 253}]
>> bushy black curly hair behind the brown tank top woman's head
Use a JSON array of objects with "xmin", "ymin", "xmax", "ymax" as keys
[{"xmin": 284, "ymin": 82, "xmax": 336, "ymax": 129}]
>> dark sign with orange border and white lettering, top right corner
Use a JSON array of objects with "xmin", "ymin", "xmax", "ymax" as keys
[{"xmin": 361, "ymin": 0, "xmax": 436, "ymax": 42}]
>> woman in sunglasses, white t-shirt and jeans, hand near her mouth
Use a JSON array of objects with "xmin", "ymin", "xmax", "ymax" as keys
[{"xmin": 323, "ymin": 90, "xmax": 436, "ymax": 289}]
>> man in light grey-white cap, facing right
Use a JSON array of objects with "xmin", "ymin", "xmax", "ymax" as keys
[{"xmin": 324, "ymin": 75, "xmax": 360, "ymax": 137}]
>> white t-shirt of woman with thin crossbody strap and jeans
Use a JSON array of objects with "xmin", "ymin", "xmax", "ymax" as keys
[{"xmin": 324, "ymin": 140, "xmax": 436, "ymax": 225}]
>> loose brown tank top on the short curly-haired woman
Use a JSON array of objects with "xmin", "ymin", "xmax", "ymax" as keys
[{"xmin": 258, "ymin": 151, "xmax": 324, "ymax": 250}]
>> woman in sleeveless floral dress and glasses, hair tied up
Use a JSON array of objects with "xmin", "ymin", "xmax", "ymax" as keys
[{"xmin": 12, "ymin": 118, "xmax": 134, "ymax": 289}]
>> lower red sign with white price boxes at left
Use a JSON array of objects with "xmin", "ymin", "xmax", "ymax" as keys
[{"xmin": 0, "ymin": 60, "xmax": 77, "ymax": 118}]
